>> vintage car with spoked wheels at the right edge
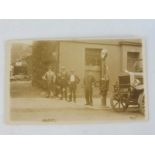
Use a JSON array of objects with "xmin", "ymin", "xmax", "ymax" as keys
[{"xmin": 110, "ymin": 72, "xmax": 144, "ymax": 114}]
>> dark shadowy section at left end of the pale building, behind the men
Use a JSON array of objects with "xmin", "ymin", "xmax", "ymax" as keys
[{"xmin": 32, "ymin": 41, "xmax": 59, "ymax": 88}]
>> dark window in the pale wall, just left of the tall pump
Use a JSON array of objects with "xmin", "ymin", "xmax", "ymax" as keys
[{"xmin": 85, "ymin": 48, "xmax": 101, "ymax": 66}]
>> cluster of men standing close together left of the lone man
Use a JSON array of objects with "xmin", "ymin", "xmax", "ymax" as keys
[{"xmin": 43, "ymin": 66, "xmax": 80, "ymax": 102}]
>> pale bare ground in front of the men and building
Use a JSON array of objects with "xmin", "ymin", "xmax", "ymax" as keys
[{"xmin": 10, "ymin": 81, "xmax": 144, "ymax": 123}]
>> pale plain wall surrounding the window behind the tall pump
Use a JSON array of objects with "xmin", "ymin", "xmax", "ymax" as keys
[{"xmin": 59, "ymin": 41, "xmax": 121, "ymax": 96}]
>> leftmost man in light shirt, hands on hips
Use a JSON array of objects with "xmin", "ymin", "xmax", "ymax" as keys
[{"xmin": 42, "ymin": 66, "xmax": 56, "ymax": 97}]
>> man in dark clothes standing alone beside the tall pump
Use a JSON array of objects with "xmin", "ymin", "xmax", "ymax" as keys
[{"xmin": 84, "ymin": 70, "xmax": 95, "ymax": 105}]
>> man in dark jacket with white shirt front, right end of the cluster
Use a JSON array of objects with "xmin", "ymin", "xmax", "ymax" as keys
[{"xmin": 68, "ymin": 70, "xmax": 80, "ymax": 102}]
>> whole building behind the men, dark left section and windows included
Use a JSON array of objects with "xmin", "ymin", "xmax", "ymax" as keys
[{"xmin": 32, "ymin": 39, "xmax": 142, "ymax": 95}]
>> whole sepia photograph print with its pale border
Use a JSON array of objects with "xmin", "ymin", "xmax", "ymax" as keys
[{"xmin": 6, "ymin": 38, "xmax": 148, "ymax": 124}]
